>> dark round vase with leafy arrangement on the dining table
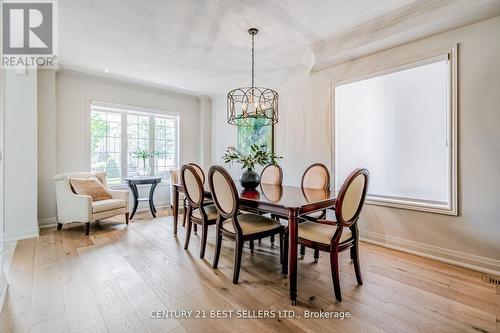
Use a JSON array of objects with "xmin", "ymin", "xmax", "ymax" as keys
[{"xmin": 223, "ymin": 144, "xmax": 282, "ymax": 190}]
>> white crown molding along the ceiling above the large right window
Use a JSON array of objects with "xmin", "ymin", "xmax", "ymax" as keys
[{"xmin": 303, "ymin": 0, "xmax": 500, "ymax": 72}]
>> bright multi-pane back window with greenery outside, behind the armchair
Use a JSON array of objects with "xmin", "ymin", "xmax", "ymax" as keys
[{"xmin": 90, "ymin": 101, "xmax": 179, "ymax": 184}]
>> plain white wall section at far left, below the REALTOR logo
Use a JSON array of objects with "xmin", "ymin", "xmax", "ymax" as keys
[{"xmin": 4, "ymin": 69, "xmax": 38, "ymax": 240}]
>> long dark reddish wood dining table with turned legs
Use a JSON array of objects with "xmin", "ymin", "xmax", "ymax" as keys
[{"xmin": 171, "ymin": 182, "xmax": 336, "ymax": 305}]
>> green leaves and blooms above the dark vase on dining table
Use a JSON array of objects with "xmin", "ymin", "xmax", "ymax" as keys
[{"xmin": 223, "ymin": 144, "xmax": 283, "ymax": 170}]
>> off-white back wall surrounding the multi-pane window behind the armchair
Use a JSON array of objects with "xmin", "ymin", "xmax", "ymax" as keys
[{"xmin": 38, "ymin": 70, "xmax": 207, "ymax": 225}]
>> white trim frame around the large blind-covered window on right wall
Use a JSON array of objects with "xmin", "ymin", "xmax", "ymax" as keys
[{"xmin": 331, "ymin": 45, "xmax": 458, "ymax": 216}]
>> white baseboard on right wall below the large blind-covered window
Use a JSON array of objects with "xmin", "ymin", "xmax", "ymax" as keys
[{"xmin": 360, "ymin": 231, "xmax": 500, "ymax": 276}]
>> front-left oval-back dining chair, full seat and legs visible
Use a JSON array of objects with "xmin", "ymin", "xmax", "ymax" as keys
[{"xmin": 208, "ymin": 166, "xmax": 288, "ymax": 284}]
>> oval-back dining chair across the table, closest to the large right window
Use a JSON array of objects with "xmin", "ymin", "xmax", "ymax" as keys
[{"xmin": 300, "ymin": 163, "xmax": 330, "ymax": 262}]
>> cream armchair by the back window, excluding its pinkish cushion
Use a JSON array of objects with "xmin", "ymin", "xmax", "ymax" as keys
[{"xmin": 54, "ymin": 172, "xmax": 129, "ymax": 235}]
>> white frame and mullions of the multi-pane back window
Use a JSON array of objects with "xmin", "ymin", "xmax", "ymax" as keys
[{"xmin": 86, "ymin": 98, "xmax": 181, "ymax": 187}]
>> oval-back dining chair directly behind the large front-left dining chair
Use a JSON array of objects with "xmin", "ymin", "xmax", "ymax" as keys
[{"xmin": 181, "ymin": 165, "xmax": 217, "ymax": 258}]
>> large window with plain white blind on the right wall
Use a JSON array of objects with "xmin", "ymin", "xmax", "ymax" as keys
[{"xmin": 334, "ymin": 50, "xmax": 456, "ymax": 214}]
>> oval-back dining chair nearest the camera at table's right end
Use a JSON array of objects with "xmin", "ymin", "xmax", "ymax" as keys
[{"xmin": 298, "ymin": 169, "xmax": 370, "ymax": 302}]
